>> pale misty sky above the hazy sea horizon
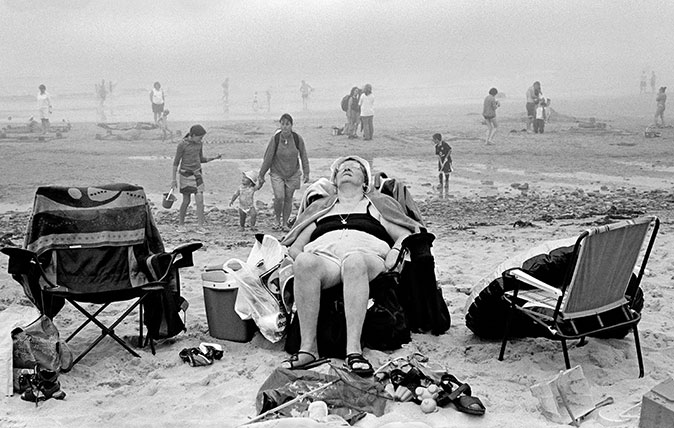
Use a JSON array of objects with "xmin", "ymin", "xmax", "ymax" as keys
[{"xmin": 0, "ymin": 0, "xmax": 674, "ymax": 97}]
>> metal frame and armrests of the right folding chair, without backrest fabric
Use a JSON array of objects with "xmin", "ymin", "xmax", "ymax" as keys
[{"xmin": 498, "ymin": 216, "xmax": 660, "ymax": 378}]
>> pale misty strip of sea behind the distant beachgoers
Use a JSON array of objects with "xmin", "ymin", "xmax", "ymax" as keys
[{"xmin": 0, "ymin": 70, "xmax": 636, "ymax": 124}]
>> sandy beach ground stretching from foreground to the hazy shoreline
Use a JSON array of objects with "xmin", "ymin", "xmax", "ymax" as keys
[{"xmin": 0, "ymin": 96, "xmax": 674, "ymax": 427}]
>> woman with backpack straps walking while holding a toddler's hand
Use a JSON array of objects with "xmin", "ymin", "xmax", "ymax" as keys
[{"xmin": 257, "ymin": 113, "xmax": 309, "ymax": 231}]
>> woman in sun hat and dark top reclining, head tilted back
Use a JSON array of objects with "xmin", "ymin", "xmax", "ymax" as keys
[{"xmin": 281, "ymin": 156, "xmax": 421, "ymax": 376}]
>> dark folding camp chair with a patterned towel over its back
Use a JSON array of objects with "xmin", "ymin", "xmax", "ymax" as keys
[{"xmin": 2, "ymin": 184, "xmax": 201, "ymax": 364}]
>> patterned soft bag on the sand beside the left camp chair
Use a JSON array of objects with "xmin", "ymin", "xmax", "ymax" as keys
[{"xmin": 12, "ymin": 315, "xmax": 73, "ymax": 372}]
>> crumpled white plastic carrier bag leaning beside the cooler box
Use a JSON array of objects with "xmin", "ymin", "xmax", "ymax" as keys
[{"xmin": 222, "ymin": 259, "xmax": 287, "ymax": 343}]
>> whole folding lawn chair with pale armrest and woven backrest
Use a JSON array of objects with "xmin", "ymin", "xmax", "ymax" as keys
[{"xmin": 499, "ymin": 217, "xmax": 660, "ymax": 377}]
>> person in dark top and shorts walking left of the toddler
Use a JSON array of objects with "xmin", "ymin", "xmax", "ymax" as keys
[{"xmin": 171, "ymin": 125, "xmax": 222, "ymax": 232}]
